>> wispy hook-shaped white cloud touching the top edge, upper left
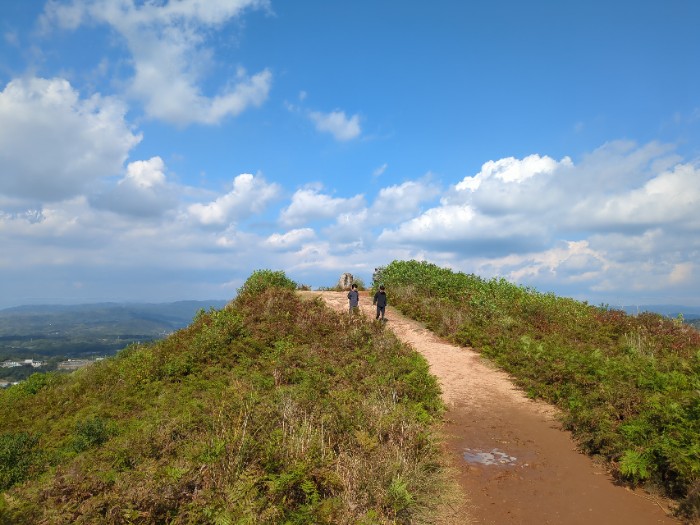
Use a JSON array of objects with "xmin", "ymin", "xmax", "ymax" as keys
[{"xmin": 43, "ymin": 0, "xmax": 272, "ymax": 125}]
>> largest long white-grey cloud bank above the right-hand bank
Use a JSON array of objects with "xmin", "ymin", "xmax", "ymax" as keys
[{"xmin": 383, "ymin": 142, "xmax": 700, "ymax": 251}]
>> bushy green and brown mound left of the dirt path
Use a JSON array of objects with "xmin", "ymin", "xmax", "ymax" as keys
[{"xmin": 0, "ymin": 270, "xmax": 449, "ymax": 524}]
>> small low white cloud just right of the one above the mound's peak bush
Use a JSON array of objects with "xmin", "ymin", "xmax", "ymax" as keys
[{"xmin": 280, "ymin": 188, "xmax": 364, "ymax": 226}]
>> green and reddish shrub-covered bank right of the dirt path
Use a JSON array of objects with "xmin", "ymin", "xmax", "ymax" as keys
[{"xmin": 375, "ymin": 261, "xmax": 700, "ymax": 518}]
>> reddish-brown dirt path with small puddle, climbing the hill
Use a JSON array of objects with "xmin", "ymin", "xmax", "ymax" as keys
[{"xmin": 309, "ymin": 292, "xmax": 680, "ymax": 525}]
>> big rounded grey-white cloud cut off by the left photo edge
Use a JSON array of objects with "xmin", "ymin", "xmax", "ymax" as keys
[{"xmin": 0, "ymin": 77, "xmax": 141, "ymax": 201}]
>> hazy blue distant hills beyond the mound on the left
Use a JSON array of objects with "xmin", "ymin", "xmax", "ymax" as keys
[{"xmin": 0, "ymin": 300, "xmax": 227, "ymax": 359}]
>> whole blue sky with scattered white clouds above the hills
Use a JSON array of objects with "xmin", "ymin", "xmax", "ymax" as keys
[{"xmin": 0, "ymin": 0, "xmax": 700, "ymax": 307}]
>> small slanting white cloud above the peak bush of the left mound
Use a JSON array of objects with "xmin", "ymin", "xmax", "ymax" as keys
[{"xmin": 187, "ymin": 173, "xmax": 280, "ymax": 226}]
